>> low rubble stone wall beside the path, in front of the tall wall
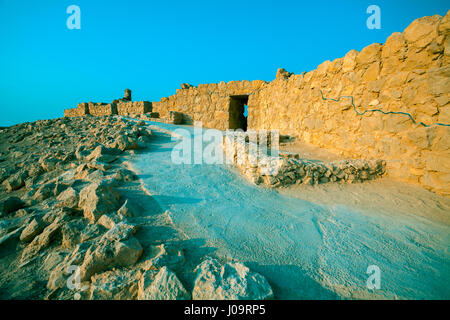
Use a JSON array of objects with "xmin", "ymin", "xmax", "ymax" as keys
[{"xmin": 223, "ymin": 135, "xmax": 386, "ymax": 187}]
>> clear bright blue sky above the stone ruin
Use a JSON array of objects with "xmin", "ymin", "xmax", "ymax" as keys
[{"xmin": 0, "ymin": 0, "xmax": 450, "ymax": 126}]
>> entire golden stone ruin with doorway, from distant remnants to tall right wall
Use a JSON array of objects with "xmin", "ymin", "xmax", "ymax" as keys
[{"xmin": 64, "ymin": 11, "xmax": 450, "ymax": 196}]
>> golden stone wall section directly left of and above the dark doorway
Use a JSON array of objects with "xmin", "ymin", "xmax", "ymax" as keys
[{"xmin": 153, "ymin": 80, "xmax": 266, "ymax": 130}]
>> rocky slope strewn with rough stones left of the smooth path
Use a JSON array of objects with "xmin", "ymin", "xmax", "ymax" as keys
[{"xmin": 0, "ymin": 116, "xmax": 273, "ymax": 299}]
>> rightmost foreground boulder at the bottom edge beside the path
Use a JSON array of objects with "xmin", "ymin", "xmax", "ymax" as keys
[{"xmin": 192, "ymin": 258, "xmax": 273, "ymax": 300}]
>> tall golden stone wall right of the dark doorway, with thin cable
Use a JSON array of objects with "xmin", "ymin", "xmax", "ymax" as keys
[{"xmin": 248, "ymin": 12, "xmax": 450, "ymax": 195}]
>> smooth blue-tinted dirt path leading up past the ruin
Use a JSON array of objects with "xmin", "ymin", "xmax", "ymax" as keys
[{"xmin": 132, "ymin": 122, "xmax": 450, "ymax": 299}]
